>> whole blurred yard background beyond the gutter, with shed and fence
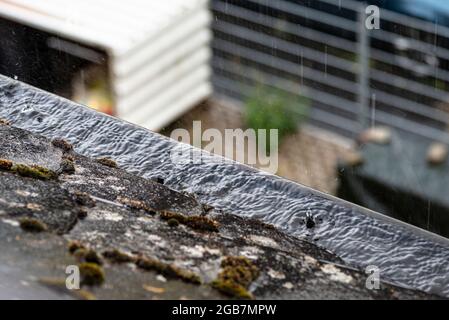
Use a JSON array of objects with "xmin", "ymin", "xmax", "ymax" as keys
[{"xmin": 0, "ymin": 0, "xmax": 449, "ymax": 236}]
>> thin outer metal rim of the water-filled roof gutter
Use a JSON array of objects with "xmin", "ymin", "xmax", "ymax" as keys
[{"xmin": 0, "ymin": 74, "xmax": 449, "ymax": 246}]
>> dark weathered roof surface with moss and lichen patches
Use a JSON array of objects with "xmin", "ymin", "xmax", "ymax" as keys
[{"xmin": 0, "ymin": 123, "xmax": 433, "ymax": 299}]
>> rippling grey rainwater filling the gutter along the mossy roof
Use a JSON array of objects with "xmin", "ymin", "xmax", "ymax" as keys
[{"xmin": 0, "ymin": 77, "xmax": 449, "ymax": 296}]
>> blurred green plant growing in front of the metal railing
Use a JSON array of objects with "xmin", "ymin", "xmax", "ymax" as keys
[{"xmin": 244, "ymin": 86, "xmax": 310, "ymax": 152}]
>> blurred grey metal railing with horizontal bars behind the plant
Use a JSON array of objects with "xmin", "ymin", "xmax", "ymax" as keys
[{"xmin": 211, "ymin": 0, "xmax": 449, "ymax": 142}]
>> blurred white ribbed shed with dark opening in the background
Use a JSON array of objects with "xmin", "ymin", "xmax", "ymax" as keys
[{"xmin": 0, "ymin": 0, "xmax": 211, "ymax": 130}]
